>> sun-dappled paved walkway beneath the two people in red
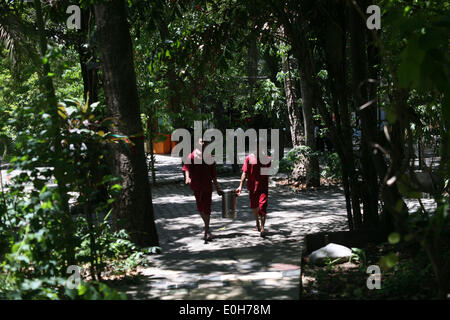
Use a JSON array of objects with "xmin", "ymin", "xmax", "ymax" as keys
[{"xmin": 122, "ymin": 177, "xmax": 347, "ymax": 300}]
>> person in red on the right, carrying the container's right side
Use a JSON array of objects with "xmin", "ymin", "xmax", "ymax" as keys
[{"xmin": 236, "ymin": 149, "xmax": 270, "ymax": 237}]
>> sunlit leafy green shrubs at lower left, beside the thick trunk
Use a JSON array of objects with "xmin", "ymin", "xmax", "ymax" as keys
[{"xmin": 0, "ymin": 94, "xmax": 140, "ymax": 299}]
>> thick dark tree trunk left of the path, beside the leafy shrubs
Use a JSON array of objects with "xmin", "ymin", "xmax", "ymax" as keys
[{"xmin": 95, "ymin": 0, "xmax": 158, "ymax": 246}]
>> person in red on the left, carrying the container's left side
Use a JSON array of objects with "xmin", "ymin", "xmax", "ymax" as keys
[{"xmin": 183, "ymin": 139, "xmax": 223, "ymax": 241}]
